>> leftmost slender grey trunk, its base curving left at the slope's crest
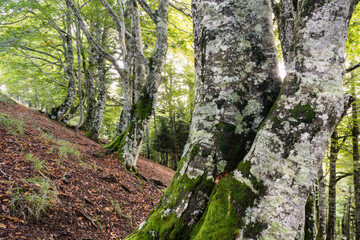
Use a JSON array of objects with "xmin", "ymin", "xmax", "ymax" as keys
[{"xmin": 48, "ymin": 5, "xmax": 76, "ymax": 121}]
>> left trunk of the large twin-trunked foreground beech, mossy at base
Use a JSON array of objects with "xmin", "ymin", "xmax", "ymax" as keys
[{"xmin": 126, "ymin": 1, "xmax": 280, "ymax": 239}]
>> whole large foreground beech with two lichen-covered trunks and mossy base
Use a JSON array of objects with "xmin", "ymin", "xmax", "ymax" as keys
[{"xmin": 128, "ymin": 0, "xmax": 358, "ymax": 240}]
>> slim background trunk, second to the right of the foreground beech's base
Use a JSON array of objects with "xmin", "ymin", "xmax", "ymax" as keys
[{"xmin": 316, "ymin": 164, "xmax": 326, "ymax": 240}]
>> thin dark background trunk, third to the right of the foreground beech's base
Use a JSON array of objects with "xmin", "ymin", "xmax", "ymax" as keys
[{"xmin": 326, "ymin": 131, "xmax": 338, "ymax": 240}]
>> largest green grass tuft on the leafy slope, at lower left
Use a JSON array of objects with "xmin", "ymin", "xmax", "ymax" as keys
[{"xmin": 9, "ymin": 178, "xmax": 58, "ymax": 221}]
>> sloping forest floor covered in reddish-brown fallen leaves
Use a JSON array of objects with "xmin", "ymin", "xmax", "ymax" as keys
[{"xmin": 0, "ymin": 93, "xmax": 174, "ymax": 240}]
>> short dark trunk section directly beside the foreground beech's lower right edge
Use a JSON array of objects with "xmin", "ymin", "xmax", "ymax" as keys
[{"xmin": 304, "ymin": 191, "xmax": 315, "ymax": 240}]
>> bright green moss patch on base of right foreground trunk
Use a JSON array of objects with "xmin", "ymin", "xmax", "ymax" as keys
[{"xmin": 190, "ymin": 171, "xmax": 265, "ymax": 240}]
